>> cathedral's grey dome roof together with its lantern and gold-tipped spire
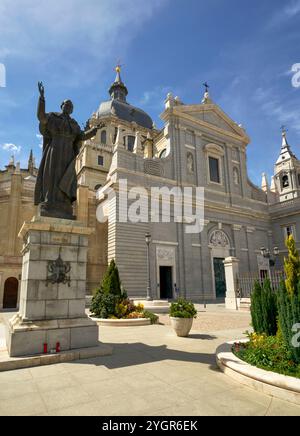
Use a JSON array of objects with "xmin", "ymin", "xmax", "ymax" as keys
[{"xmin": 97, "ymin": 67, "xmax": 153, "ymax": 129}]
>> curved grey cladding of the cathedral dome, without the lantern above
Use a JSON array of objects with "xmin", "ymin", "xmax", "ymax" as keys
[{"xmin": 97, "ymin": 100, "xmax": 153, "ymax": 129}]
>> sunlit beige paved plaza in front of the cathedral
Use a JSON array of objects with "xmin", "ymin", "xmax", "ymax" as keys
[{"xmin": 0, "ymin": 305, "xmax": 300, "ymax": 416}]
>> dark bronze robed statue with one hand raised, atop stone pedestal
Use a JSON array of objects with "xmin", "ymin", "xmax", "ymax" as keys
[{"xmin": 35, "ymin": 82, "xmax": 98, "ymax": 219}]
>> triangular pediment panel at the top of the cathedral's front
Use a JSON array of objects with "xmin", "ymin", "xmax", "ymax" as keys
[{"xmin": 176, "ymin": 104, "xmax": 249, "ymax": 140}]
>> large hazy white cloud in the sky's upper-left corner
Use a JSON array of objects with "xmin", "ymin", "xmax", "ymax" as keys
[{"xmin": 0, "ymin": 0, "xmax": 169, "ymax": 86}]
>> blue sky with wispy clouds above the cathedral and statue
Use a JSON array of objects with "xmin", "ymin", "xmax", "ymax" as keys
[{"xmin": 0, "ymin": 0, "xmax": 300, "ymax": 184}]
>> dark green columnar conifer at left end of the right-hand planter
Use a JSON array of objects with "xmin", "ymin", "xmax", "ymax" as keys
[{"xmin": 251, "ymin": 279, "xmax": 278, "ymax": 336}]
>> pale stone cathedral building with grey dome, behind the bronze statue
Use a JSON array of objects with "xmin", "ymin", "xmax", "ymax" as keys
[{"xmin": 0, "ymin": 67, "xmax": 300, "ymax": 308}]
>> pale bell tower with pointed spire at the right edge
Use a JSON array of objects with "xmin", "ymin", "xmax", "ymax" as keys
[{"xmin": 275, "ymin": 126, "xmax": 300, "ymax": 202}]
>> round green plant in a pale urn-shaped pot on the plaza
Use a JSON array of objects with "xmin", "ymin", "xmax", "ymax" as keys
[{"xmin": 169, "ymin": 298, "xmax": 197, "ymax": 338}]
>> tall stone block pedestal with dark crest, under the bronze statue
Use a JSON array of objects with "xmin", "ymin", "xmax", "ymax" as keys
[{"xmin": 6, "ymin": 217, "xmax": 99, "ymax": 357}]
